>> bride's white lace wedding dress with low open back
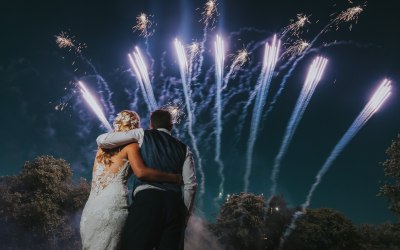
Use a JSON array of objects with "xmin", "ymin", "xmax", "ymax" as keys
[{"xmin": 80, "ymin": 161, "xmax": 130, "ymax": 250}]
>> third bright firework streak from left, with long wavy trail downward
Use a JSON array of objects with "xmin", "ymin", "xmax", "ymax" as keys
[{"xmin": 174, "ymin": 39, "xmax": 205, "ymax": 201}]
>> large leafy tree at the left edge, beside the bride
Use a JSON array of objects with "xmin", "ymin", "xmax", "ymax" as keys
[{"xmin": 0, "ymin": 156, "xmax": 90, "ymax": 249}]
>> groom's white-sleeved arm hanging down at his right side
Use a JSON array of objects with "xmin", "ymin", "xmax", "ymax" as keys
[{"xmin": 182, "ymin": 148, "xmax": 197, "ymax": 219}]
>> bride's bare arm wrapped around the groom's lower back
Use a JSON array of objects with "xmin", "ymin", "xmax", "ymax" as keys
[{"xmin": 124, "ymin": 143, "xmax": 182, "ymax": 185}]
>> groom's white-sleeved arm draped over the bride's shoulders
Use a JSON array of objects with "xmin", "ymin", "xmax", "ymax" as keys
[{"xmin": 96, "ymin": 128, "xmax": 144, "ymax": 148}]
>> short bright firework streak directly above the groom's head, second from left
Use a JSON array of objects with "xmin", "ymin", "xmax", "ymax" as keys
[{"xmin": 128, "ymin": 47, "xmax": 157, "ymax": 112}]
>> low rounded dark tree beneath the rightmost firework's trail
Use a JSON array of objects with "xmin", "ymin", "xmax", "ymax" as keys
[{"xmin": 283, "ymin": 208, "xmax": 360, "ymax": 250}]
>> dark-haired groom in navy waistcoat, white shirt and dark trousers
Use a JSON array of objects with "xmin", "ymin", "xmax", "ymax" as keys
[{"xmin": 97, "ymin": 110, "xmax": 197, "ymax": 250}]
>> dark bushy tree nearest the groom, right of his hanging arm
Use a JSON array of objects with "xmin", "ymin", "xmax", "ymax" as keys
[{"xmin": 211, "ymin": 193, "xmax": 267, "ymax": 250}]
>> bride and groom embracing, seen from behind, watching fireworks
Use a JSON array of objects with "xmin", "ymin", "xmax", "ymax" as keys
[{"xmin": 80, "ymin": 110, "xmax": 197, "ymax": 250}]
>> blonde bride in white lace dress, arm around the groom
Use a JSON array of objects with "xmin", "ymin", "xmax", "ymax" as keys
[{"xmin": 80, "ymin": 110, "xmax": 182, "ymax": 250}]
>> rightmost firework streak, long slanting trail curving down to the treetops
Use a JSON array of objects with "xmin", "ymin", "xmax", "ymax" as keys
[{"xmin": 280, "ymin": 79, "xmax": 391, "ymax": 248}]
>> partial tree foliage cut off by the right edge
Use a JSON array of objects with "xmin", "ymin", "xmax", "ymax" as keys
[{"xmin": 378, "ymin": 134, "xmax": 400, "ymax": 219}]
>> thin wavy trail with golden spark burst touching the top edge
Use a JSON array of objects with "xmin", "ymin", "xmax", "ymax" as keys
[{"xmin": 193, "ymin": 0, "xmax": 218, "ymax": 81}]
